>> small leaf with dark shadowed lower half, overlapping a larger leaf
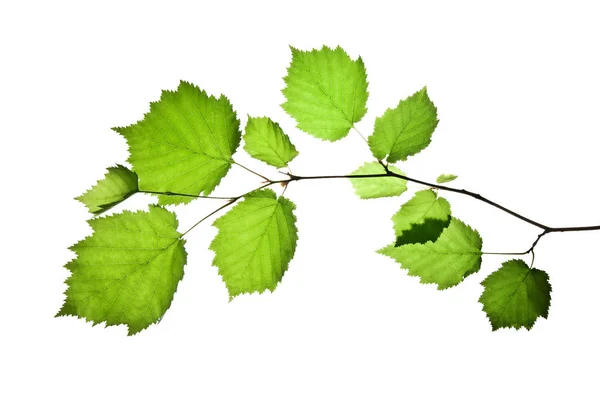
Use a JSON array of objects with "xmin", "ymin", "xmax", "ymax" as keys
[{"xmin": 392, "ymin": 189, "xmax": 450, "ymax": 246}]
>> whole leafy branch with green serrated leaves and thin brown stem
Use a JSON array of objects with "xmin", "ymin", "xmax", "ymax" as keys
[{"xmin": 58, "ymin": 47, "xmax": 600, "ymax": 335}]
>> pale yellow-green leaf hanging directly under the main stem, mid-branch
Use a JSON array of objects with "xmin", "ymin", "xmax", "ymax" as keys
[{"xmin": 350, "ymin": 162, "xmax": 406, "ymax": 199}]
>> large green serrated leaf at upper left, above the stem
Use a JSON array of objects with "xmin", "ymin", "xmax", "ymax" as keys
[{"xmin": 114, "ymin": 81, "xmax": 241, "ymax": 203}]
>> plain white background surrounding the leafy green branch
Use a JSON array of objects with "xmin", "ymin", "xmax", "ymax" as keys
[{"xmin": 0, "ymin": 0, "xmax": 600, "ymax": 400}]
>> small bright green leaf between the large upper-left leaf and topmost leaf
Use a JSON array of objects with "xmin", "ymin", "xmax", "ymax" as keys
[{"xmin": 244, "ymin": 116, "xmax": 298, "ymax": 168}]
